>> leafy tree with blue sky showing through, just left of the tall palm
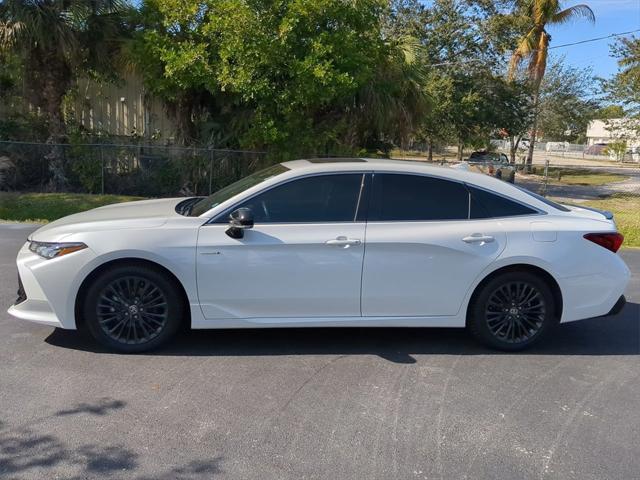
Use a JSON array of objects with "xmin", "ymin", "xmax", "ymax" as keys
[{"xmin": 412, "ymin": 0, "xmax": 529, "ymax": 159}]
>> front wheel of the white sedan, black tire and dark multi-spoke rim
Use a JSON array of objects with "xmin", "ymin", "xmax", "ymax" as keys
[{"xmin": 82, "ymin": 265, "xmax": 185, "ymax": 353}]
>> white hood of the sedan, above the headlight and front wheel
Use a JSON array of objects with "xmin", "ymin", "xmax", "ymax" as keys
[{"xmin": 29, "ymin": 198, "xmax": 184, "ymax": 242}]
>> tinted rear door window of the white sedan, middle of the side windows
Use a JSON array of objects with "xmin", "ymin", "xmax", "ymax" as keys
[{"xmin": 369, "ymin": 173, "xmax": 469, "ymax": 221}]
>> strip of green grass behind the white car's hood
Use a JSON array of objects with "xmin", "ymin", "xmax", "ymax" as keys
[{"xmin": 0, "ymin": 192, "xmax": 142, "ymax": 222}]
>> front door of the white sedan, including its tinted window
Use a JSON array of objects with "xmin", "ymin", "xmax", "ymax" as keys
[{"xmin": 197, "ymin": 173, "xmax": 365, "ymax": 319}]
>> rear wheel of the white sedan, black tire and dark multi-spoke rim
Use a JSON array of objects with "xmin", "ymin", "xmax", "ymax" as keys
[{"xmin": 467, "ymin": 271, "xmax": 558, "ymax": 351}]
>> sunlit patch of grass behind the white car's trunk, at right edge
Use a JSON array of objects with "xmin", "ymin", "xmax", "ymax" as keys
[{"xmin": 557, "ymin": 194, "xmax": 640, "ymax": 247}]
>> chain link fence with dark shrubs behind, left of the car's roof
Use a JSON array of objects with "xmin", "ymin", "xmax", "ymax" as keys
[{"xmin": 0, "ymin": 141, "xmax": 273, "ymax": 197}]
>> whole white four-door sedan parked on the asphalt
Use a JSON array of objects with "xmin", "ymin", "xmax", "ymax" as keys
[{"xmin": 9, "ymin": 159, "xmax": 629, "ymax": 352}]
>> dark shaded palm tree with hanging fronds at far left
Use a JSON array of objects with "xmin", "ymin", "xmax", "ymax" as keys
[{"xmin": 0, "ymin": 0, "xmax": 130, "ymax": 190}]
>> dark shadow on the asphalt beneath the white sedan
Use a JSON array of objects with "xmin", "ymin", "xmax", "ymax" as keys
[{"xmin": 45, "ymin": 303, "xmax": 640, "ymax": 363}]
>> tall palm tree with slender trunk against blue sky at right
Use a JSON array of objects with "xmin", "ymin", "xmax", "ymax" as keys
[{"xmin": 508, "ymin": 0, "xmax": 596, "ymax": 170}]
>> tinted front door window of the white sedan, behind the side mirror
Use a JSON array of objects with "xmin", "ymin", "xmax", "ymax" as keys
[{"xmin": 238, "ymin": 174, "xmax": 363, "ymax": 223}]
